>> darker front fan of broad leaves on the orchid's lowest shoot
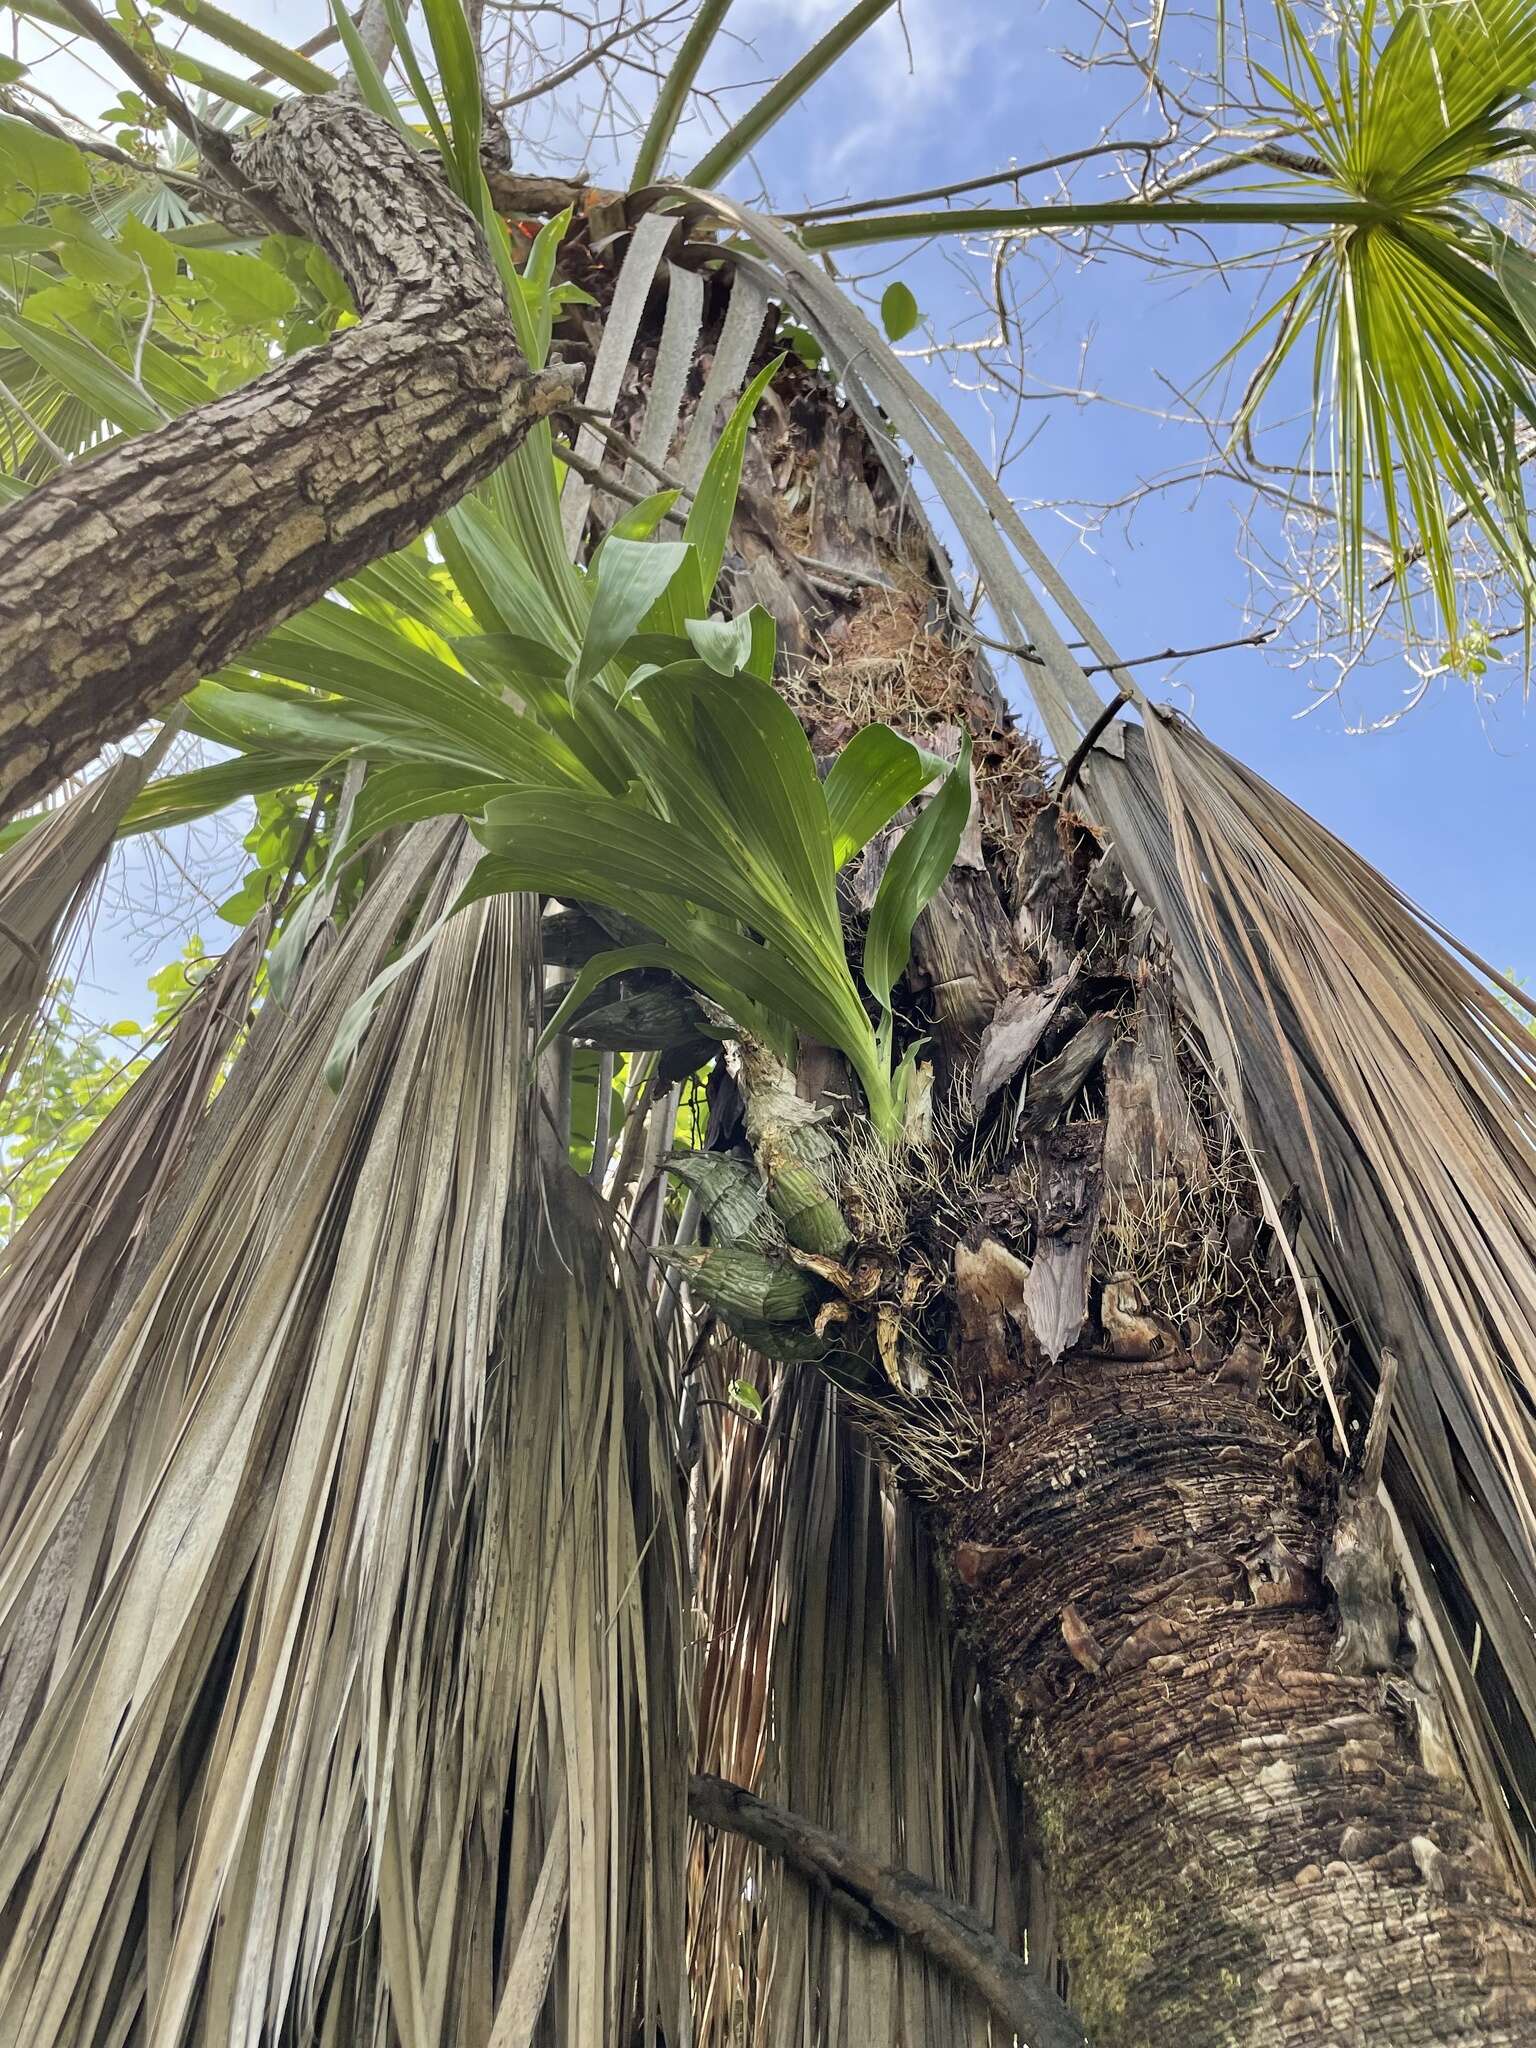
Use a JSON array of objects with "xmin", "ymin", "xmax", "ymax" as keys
[{"xmin": 471, "ymin": 662, "xmax": 969, "ymax": 1139}]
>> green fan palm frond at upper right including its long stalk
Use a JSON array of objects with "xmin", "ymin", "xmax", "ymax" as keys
[{"xmin": 801, "ymin": 0, "xmax": 1536, "ymax": 647}]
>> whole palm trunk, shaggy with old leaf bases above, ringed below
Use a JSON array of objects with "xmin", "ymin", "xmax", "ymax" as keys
[{"xmin": 692, "ymin": 327, "xmax": 1536, "ymax": 2048}]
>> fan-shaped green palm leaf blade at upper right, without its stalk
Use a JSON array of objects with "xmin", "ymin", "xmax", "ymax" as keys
[{"xmin": 1243, "ymin": 0, "xmax": 1536, "ymax": 639}]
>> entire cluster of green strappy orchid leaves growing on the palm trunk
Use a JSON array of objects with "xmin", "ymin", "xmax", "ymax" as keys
[{"xmin": 190, "ymin": 352, "xmax": 969, "ymax": 1139}]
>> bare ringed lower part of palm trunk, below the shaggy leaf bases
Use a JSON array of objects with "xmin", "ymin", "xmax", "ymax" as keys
[{"xmin": 946, "ymin": 1339, "xmax": 1536, "ymax": 2048}]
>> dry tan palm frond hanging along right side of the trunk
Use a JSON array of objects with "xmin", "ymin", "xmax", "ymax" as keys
[{"xmin": 1092, "ymin": 719, "xmax": 1536, "ymax": 1868}]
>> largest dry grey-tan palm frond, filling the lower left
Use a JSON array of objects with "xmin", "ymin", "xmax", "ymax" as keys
[{"xmin": 0, "ymin": 827, "xmax": 682, "ymax": 2048}]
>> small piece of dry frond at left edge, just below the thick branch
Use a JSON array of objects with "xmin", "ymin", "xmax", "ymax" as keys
[{"xmin": 0, "ymin": 725, "xmax": 174, "ymax": 1096}]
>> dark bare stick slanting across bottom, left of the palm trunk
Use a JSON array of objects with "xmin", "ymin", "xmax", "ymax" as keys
[{"xmin": 688, "ymin": 1778, "xmax": 1087, "ymax": 2048}]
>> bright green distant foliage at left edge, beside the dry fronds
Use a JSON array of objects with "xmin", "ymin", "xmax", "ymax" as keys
[{"xmin": 0, "ymin": 938, "xmax": 207, "ymax": 1243}]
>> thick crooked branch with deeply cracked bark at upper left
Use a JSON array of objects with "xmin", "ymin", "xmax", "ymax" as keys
[{"xmin": 0, "ymin": 94, "xmax": 573, "ymax": 817}]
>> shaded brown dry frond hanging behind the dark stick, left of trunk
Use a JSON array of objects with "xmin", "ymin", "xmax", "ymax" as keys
[{"xmin": 688, "ymin": 1368, "xmax": 1022, "ymax": 2048}]
